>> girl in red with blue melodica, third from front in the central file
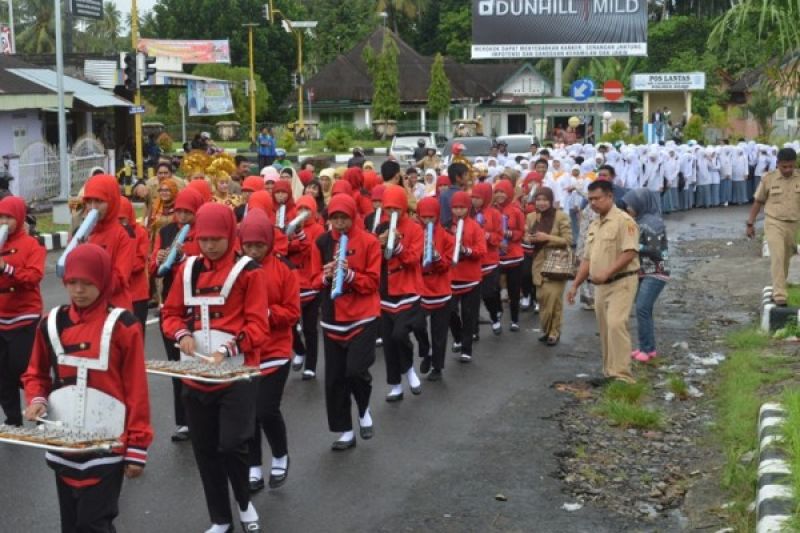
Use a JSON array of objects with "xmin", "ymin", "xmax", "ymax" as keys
[{"xmin": 417, "ymin": 197, "xmax": 455, "ymax": 381}]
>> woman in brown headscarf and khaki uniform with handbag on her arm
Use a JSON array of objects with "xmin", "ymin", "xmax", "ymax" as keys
[{"xmin": 525, "ymin": 187, "xmax": 572, "ymax": 346}]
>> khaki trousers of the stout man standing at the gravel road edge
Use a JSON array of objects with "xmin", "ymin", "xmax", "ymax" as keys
[{"xmin": 594, "ymin": 275, "xmax": 639, "ymax": 383}]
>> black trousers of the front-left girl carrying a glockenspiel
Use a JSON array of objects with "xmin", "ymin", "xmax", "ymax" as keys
[{"xmin": 56, "ymin": 462, "xmax": 124, "ymax": 533}]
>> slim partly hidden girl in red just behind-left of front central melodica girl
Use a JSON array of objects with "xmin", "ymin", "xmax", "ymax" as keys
[{"xmin": 289, "ymin": 195, "xmax": 325, "ymax": 380}]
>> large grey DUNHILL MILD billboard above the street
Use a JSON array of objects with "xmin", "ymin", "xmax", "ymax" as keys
[{"xmin": 472, "ymin": 0, "xmax": 647, "ymax": 59}]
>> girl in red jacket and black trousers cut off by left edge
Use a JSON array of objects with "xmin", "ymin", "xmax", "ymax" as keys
[{"xmin": 0, "ymin": 196, "xmax": 47, "ymax": 426}]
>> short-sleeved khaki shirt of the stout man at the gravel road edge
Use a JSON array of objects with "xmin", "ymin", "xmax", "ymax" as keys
[{"xmin": 583, "ymin": 206, "xmax": 639, "ymax": 277}]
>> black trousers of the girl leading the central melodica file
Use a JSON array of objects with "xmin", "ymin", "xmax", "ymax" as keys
[{"xmin": 323, "ymin": 320, "xmax": 380, "ymax": 432}]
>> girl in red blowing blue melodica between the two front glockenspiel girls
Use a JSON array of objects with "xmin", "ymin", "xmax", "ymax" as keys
[{"xmin": 150, "ymin": 189, "xmax": 203, "ymax": 442}]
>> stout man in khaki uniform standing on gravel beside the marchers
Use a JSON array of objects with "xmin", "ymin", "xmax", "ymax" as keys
[{"xmin": 567, "ymin": 179, "xmax": 639, "ymax": 384}]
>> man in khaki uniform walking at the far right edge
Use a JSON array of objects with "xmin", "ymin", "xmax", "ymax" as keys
[{"xmin": 747, "ymin": 148, "xmax": 800, "ymax": 306}]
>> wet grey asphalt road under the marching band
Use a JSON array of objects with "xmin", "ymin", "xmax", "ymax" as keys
[{"xmin": 0, "ymin": 208, "xmax": 744, "ymax": 533}]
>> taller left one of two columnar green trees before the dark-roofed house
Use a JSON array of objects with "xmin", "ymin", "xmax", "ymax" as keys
[{"xmin": 363, "ymin": 32, "xmax": 400, "ymax": 138}]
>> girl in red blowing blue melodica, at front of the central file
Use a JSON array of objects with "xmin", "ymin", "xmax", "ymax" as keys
[{"xmin": 311, "ymin": 194, "xmax": 381, "ymax": 450}]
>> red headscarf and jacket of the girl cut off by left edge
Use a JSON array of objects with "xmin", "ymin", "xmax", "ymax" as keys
[{"xmin": 0, "ymin": 196, "xmax": 47, "ymax": 331}]
